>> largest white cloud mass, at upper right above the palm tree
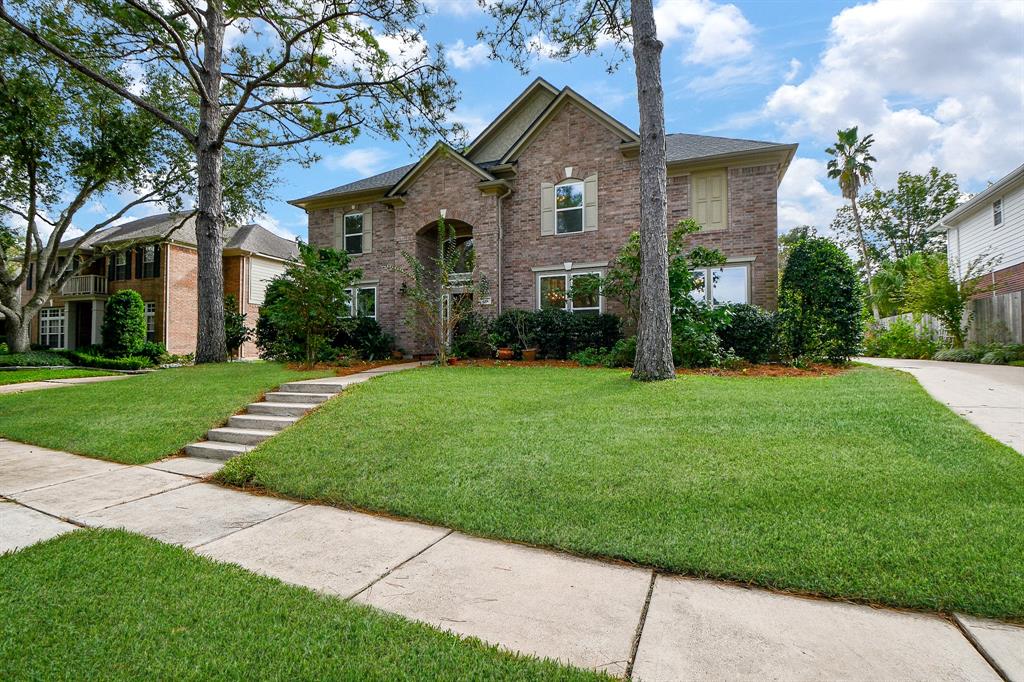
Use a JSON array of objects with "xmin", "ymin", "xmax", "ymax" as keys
[{"xmin": 762, "ymin": 0, "xmax": 1024, "ymax": 228}]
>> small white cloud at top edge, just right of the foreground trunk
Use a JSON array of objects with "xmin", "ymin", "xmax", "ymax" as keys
[{"xmin": 654, "ymin": 0, "xmax": 754, "ymax": 65}]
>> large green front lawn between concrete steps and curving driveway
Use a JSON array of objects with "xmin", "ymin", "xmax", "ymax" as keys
[{"xmin": 220, "ymin": 368, "xmax": 1024, "ymax": 620}]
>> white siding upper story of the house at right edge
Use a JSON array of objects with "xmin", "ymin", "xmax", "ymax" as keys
[{"xmin": 932, "ymin": 165, "xmax": 1024, "ymax": 279}]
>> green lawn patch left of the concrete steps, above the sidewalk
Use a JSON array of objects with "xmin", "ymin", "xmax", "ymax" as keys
[{"xmin": 0, "ymin": 363, "xmax": 329, "ymax": 464}]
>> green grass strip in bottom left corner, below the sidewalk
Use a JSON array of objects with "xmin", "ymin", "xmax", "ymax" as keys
[{"xmin": 0, "ymin": 530, "xmax": 608, "ymax": 680}]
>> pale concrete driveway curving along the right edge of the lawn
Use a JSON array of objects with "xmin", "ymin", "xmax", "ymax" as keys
[{"xmin": 857, "ymin": 357, "xmax": 1024, "ymax": 455}]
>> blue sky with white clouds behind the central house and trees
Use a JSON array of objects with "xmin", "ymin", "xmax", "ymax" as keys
[{"xmin": 86, "ymin": 0, "xmax": 1024, "ymax": 239}]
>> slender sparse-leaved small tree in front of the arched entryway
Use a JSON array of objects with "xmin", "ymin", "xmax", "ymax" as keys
[{"xmin": 390, "ymin": 216, "xmax": 489, "ymax": 367}]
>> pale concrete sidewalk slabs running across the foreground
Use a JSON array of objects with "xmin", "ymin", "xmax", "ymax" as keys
[{"xmin": 0, "ymin": 439, "xmax": 1024, "ymax": 681}]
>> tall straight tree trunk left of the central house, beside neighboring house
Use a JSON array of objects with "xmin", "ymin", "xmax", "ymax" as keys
[{"xmin": 196, "ymin": 0, "xmax": 227, "ymax": 363}]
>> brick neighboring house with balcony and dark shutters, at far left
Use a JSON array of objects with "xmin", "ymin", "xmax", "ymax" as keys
[{"xmin": 25, "ymin": 213, "xmax": 298, "ymax": 357}]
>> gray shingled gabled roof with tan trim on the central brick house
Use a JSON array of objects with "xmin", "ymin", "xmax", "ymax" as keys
[{"xmin": 289, "ymin": 78, "xmax": 797, "ymax": 210}]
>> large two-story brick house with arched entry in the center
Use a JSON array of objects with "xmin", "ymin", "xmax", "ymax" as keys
[{"xmin": 291, "ymin": 79, "xmax": 797, "ymax": 351}]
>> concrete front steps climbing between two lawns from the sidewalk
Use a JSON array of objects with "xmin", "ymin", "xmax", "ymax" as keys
[{"xmin": 185, "ymin": 382, "xmax": 345, "ymax": 460}]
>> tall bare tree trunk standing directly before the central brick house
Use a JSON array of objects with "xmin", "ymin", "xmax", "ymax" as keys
[{"xmin": 631, "ymin": 0, "xmax": 675, "ymax": 381}]
